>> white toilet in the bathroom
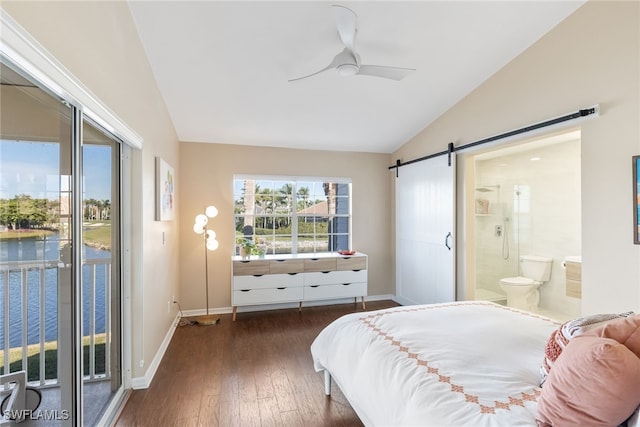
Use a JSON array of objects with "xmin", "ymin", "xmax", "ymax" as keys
[{"xmin": 500, "ymin": 255, "xmax": 553, "ymax": 312}]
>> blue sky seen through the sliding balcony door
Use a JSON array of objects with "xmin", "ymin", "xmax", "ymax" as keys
[{"xmin": 0, "ymin": 140, "xmax": 111, "ymax": 200}]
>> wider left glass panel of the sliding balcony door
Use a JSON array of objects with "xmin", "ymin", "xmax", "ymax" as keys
[{"xmin": 0, "ymin": 60, "xmax": 76, "ymax": 424}]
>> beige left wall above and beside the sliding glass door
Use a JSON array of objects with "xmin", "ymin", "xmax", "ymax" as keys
[{"xmin": 2, "ymin": 0, "xmax": 180, "ymax": 377}]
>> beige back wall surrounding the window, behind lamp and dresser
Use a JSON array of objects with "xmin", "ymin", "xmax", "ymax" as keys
[{"xmin": 179, "ymin": 142, "xmax": 395, "ymax": 310}]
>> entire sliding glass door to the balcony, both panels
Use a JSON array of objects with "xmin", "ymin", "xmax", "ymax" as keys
[{"xmin": 0, "ymin": 59, "xmax": 123, "ymax": 425}]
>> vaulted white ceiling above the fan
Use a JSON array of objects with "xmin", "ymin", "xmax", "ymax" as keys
[{"xmin": 129, "ymin": 0, "xmax": 584, "ymax": 153}]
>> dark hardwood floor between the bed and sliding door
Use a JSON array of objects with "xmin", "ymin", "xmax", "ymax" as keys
[{"xmin": 116, "ymin": 301, "xmax": 397, "ymax": 427}]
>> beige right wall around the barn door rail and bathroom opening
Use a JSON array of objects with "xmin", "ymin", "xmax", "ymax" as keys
[{"xmin": 392, "ymin": 1, "xmax": 640, "ymax": 314}]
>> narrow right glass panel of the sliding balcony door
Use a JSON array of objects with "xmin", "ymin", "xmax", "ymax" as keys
[{"xmin": 82, "ymin": 121, "xmax": 122, "ymax": 425}]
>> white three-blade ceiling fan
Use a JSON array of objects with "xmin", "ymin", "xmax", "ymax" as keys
[{"xmin": 289, "ymin": 5, "xmax": 415, "ymax": 82}]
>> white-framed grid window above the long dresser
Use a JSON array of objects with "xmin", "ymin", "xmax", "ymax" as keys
[{"xmin": 233, "ymin": 176, "xmax": 351, "ymax": 254}]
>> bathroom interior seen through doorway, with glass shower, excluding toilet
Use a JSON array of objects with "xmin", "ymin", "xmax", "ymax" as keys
[{"xmin": 465, "ymin": 130, "xmax": 582, "ymax": 319}]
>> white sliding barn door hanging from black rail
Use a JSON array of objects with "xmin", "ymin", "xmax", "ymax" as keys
[{"xmin": 396, "ymin": 153, "xmax": 456, "ymax": 305}]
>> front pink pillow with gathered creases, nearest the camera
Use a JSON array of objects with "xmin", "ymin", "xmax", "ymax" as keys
[{"xmin": 537, "ymin": 335, "xmax": 640, "ymax": 427}]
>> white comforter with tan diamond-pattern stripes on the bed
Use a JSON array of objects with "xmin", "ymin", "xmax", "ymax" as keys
[{"xmin": 311, "ymin": 301, "xmax": 558, "ymax": 427}]
